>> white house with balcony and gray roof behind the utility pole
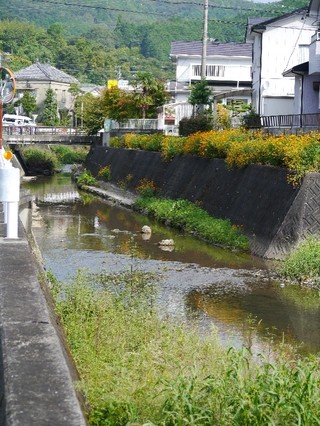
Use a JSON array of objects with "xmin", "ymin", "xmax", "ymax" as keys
[{"xmin": 170, "ymin": 41, "xmax": 252, "ymax": 103}]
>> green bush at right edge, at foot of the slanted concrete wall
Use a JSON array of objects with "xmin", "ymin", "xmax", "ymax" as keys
[{"xmin": 279, "ymin": 236, "xmax": 320, "ymax": 286}]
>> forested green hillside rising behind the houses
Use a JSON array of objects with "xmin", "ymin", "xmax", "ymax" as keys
[{"xmin": 0, "ymin": 0, "xmax": 309, "ymax": 84}]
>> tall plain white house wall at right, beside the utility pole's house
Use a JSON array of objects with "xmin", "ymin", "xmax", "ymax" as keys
[{"xmin": 246, "ymin": 8, "xmax": 314, "ymax": 116}]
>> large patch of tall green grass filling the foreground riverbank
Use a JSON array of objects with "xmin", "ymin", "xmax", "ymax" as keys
[{"xmin": 53, "ymin": 272, "xmax": 320, "ymax": 426}]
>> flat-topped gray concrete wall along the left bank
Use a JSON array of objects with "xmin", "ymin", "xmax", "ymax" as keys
[{"xmin": 0, "ymin": 201, "xmax": 87, "ymax": 426}]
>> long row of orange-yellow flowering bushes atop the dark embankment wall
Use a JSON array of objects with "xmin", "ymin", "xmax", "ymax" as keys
[{"xmin": 110, "ymin": 128, "xmax": 320, "ymax": 183}]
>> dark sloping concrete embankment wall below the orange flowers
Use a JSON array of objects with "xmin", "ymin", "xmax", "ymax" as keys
[{"xmin": 86, "ymin": 146, "xmax": 320, "ymax": 259}]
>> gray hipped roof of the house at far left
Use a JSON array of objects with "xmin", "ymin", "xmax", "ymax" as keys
[{"xmin": 14, "ymin": 62, "xmax": 78, "ymax": 83}]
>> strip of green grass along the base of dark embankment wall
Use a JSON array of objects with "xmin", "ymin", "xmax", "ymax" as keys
[{"xmin": 135, "ymin": 196, "xmax": 249, "ymax": 250}]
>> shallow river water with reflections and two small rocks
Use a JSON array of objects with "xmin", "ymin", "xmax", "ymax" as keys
[{"xmin": 24, "ymin": 174, "xmax": 320, "ymax": 353}]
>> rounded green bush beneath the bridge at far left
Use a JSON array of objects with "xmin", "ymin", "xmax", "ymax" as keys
[{"xmin": 22, "ymin": 148, "xmax": 59, "ymax": 174}]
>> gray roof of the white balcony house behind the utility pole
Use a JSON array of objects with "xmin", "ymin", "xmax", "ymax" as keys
[{"xmin": 170, "ymin": 41, "xmax": 252, "ymax": 58}]
